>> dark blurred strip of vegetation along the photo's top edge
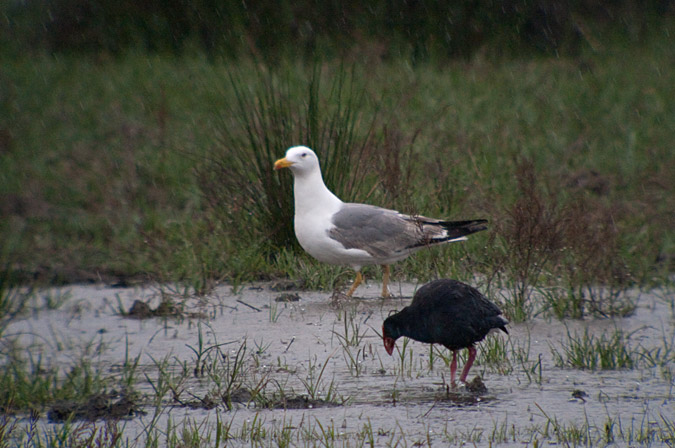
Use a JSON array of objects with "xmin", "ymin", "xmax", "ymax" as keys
[{"xmin": 5, "ymin": 0, "xmax": 672, "ymax": 63}]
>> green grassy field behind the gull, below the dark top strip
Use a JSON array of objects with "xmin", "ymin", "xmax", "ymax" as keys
[{"xmin": 0, "ymin": 27, "xmax": 675, "ymax": 304}]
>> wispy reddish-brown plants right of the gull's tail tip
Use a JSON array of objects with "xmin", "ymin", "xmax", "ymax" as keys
[{"xmin": 490, "ymin": 159, "xmax": 635, "ymax": 321}]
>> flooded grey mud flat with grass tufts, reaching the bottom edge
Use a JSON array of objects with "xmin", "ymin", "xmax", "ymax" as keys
[{"xmin": 2, "ymin": 283, "xmax": 675, "ymax": 446}]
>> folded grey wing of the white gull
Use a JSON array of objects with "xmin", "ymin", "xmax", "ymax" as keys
[{"xmin": 328, "ymin": 203, "xmax": 444, "ymax": 258}]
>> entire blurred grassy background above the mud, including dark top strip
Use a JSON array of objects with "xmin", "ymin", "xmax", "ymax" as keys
[{"xmin": 0, "ymin": 0, "xmax": 675, "ymax": 304}]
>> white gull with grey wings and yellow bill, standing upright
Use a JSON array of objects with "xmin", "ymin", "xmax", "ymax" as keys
[{"xmin": 274, "ymin": 146, "xmax": 487, "ymax": 297}]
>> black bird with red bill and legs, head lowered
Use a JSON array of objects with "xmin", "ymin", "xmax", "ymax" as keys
[{"xmin": 382, "ymin": 279, "xmax": 509, "ymax": 385}]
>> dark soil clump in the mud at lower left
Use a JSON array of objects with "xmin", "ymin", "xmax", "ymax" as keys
[{"xmin": 47, "ymin": 391, "xmax": 146, "ymax": 423}]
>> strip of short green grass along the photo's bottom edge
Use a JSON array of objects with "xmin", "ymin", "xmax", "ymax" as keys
[{"xmin": 6, "ymin": 408, "xmax": 675, "ymax": 447}]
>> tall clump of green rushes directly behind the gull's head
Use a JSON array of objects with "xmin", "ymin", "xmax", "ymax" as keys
[{"xmin": 198, "ymin": 64, "xmax": 375, "ymax": 251}]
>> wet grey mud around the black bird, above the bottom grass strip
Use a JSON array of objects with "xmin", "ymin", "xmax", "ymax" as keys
[{"xmin": 6, "ymin": 283, "xmax": 675, "ymax": 446}]
